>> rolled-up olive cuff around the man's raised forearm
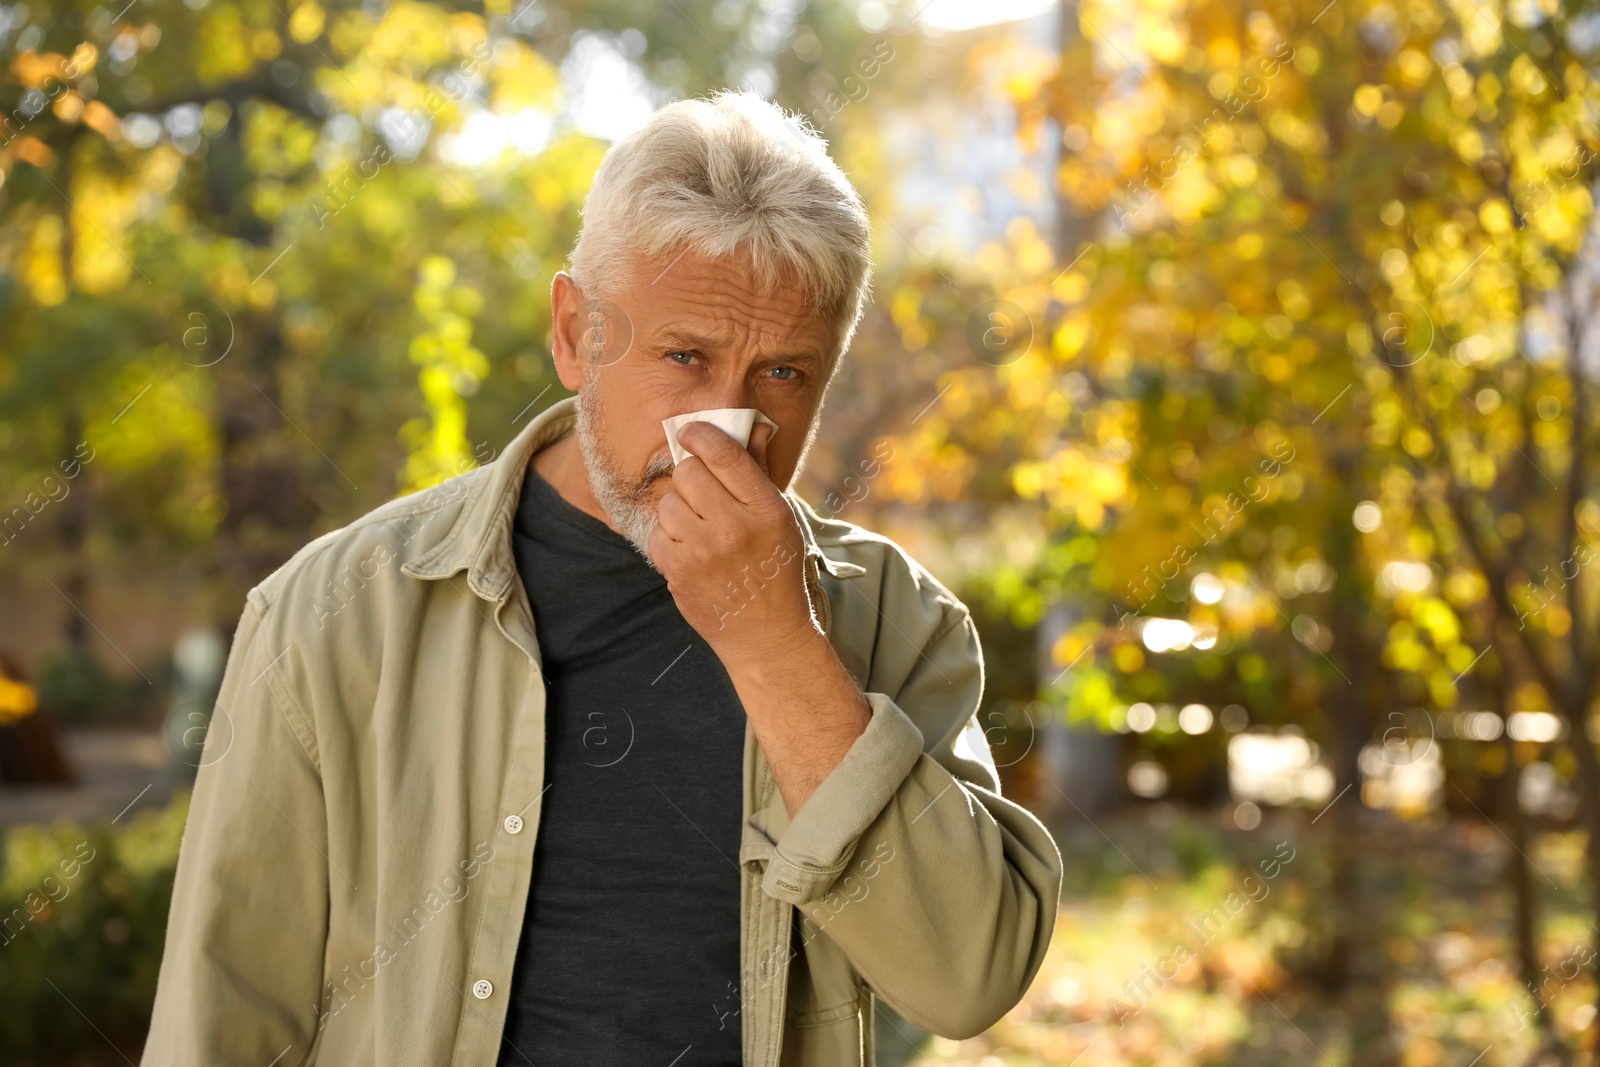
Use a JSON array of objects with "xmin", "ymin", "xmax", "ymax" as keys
[{"xmin": 762, "ymin": 693, "xmax": 923, "ymax": 904}]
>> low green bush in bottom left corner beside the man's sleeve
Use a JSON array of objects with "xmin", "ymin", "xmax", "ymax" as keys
[{"xmin": 0, "ymin": 795, "xmax": 189, "ymax": 1064}]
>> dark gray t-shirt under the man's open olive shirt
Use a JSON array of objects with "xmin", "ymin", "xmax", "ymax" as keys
[{"xmin": 499, "ymin": 464, "xmax": 746, "ymax": 1067}]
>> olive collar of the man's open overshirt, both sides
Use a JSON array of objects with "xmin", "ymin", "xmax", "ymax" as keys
[{"xmin": 402, "ymin": 397, "xmax": 866, "ymax": 600}]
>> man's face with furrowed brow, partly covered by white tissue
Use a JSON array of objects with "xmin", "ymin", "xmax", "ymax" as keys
[{"xmin": 552, "ymin": 253, "xmax": 840, "ymax": 544}]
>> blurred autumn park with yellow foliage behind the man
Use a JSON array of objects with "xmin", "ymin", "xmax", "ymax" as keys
[{"xmin": 0, "ymin": 0, "xmax": 1600, "ymax": 1067}]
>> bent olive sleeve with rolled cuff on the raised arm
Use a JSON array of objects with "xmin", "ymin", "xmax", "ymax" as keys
[{"xmin": 763, "ymin": 605, "xmax": 1061, "ymax": 1038}]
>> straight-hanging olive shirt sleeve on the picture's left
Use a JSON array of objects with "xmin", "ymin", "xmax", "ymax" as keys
[{"xmin": 142, "ymin": 593, "xmax": 328, "ymax": 1067}]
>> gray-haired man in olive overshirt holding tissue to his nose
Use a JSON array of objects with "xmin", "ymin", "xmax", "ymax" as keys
[{"xmin": 144, "ymin": 93, "xmax": 1061, "ymax": 1067}]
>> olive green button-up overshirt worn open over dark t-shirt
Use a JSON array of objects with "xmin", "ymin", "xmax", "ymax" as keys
[{"xmin": 144, "ymin": 402, "xmax": 1061, "ymax": 1067}]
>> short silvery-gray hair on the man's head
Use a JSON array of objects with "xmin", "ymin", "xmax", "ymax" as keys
[{"xmin": 570, "ymin": 90, "xmax": 872, "ymax": 352}]
